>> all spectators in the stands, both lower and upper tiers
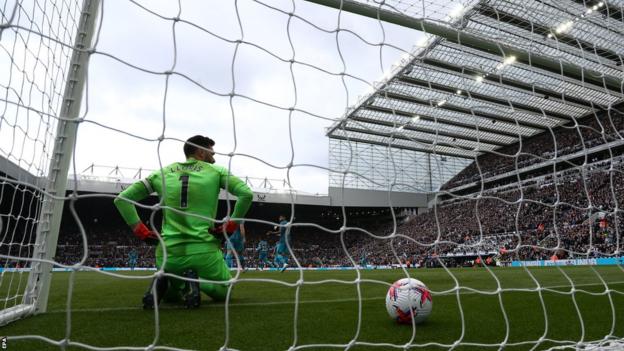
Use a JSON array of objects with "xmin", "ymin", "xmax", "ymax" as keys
[{"xmin": 6, "ymin": 111, "xmax": 624, "ymax": 268}]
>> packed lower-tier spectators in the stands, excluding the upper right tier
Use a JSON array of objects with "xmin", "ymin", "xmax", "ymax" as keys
[{"xmin": 46, "ymin": 157, "xmax": 624, "ymax": 268}]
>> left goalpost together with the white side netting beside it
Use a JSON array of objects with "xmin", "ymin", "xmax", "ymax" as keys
[{"xmin": 0, "ymin": 1, "xmax": 93, "ymax": 324}]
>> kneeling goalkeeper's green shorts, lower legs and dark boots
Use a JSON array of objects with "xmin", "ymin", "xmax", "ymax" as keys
[{"xmin": 156, "ymin": 245, "xmax": 232, "ymax": 302}]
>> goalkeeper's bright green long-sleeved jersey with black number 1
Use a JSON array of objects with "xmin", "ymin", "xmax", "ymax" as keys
[{"xmin": 115, "ymin": 158, "xmax": 253, "ymax": 253}]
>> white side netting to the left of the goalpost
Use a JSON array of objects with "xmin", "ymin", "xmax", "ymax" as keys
[{"xmin": 0, "ymin": 1, "xmax": 80, "ymax": 311}]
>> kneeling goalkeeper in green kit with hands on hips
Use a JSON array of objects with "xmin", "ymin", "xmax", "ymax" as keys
[{"xmin": 115, "ymin": 135, "xmax": 253, "ymax": 308}]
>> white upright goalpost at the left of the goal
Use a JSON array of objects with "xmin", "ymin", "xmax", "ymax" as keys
[{"xmin": 0, "ymin": 0, "xmax": 100, "ymax": 325}]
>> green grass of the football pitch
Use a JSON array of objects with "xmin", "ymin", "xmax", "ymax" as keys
[{"xmin": 0, "ymin": 266, "xmax": 624, "ymax": 350}]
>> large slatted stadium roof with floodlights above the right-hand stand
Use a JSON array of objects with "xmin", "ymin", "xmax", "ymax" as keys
[{"xmin": 316, "ymin": 0, "xmax": 624, "ymax": 157}]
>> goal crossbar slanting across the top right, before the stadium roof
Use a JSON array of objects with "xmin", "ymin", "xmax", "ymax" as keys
[{"xmin": 306, "ymin": 0, "xmax": 624, "ymax": 93}]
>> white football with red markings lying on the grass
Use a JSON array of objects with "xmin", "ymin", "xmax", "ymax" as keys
[{"xmin": 386, "ymin": 278, "xmax": 433, "ymax": 324}]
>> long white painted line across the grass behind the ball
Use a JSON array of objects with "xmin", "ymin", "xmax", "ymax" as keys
[{"xmin": 47, "ymin": 281, "xmax": 624, "ymax": 313}]
